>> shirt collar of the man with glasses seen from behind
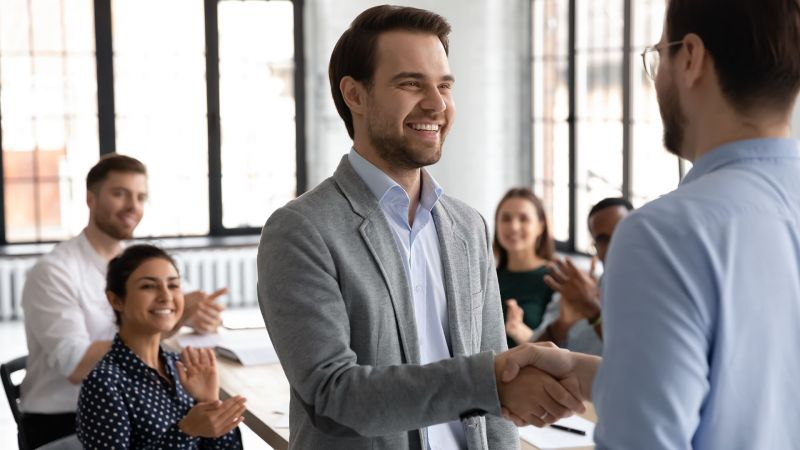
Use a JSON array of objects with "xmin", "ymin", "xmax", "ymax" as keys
[{"xmin": 681, "ymin": 138, "xmax": 800, "ymax": 184}]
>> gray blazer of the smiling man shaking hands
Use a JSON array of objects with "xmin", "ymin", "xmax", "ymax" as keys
[{"xmin": 258, "ymin": 156, "xmax": 519, "ymax": 450}]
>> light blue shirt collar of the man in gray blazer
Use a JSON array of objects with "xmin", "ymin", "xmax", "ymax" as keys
[{"xmin": 347, "ymin": 148, "xmax": 444, "ymax": 211}]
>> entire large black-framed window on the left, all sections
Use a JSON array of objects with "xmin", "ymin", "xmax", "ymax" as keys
[{"xmin": 0, "ymin": 0, "xmax": 305, "ymax": 244}]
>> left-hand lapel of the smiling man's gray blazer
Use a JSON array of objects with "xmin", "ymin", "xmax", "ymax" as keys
[{"xmin": 333, "ymin": 155, "xmax": 420, "ymax": 364}]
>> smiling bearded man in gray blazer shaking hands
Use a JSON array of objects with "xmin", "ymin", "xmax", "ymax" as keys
[{"xmin": 258, "ymin": 6, "xmax": 582, "ymax": 450}]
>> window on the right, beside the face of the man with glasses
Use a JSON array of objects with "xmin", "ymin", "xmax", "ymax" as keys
[{"xmin": 531, "ymin": 0, "xmax": 680, "ymax": 252}]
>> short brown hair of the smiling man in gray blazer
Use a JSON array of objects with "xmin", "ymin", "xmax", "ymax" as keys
[{"xmin": 328, "ymin": 5, "xmax": 450, "ymax": 139}]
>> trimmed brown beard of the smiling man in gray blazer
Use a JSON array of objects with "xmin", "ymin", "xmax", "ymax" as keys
[{"xmin": 367, "ymin": 107, "xmax": 445, "ymax": 169}]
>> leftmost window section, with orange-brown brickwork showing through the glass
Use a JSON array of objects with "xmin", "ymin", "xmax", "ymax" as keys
[{"xmin": 0, "ymin": 0, "xmax": 98, "ymax": 242}]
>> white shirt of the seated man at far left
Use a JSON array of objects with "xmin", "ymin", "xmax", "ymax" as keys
[{"xmin": 21, "ymin": 231, "xmax": 117, "ymax": 414}]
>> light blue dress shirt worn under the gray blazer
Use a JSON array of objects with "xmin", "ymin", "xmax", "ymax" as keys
[{"xmin": 348, "ymin": 149, "xmax": 466, "ymax": 450}]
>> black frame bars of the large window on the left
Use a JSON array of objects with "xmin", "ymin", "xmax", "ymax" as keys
[{"xmin": 0, "ymin": 0, "xmax": 308, "ymax": 246}]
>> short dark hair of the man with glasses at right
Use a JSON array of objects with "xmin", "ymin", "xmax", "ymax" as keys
[{"xmin": 666, "ymin": 0, "xmax": 800, "ymax": 112}]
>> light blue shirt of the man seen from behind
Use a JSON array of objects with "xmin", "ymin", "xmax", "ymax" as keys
[{"xmin": 593, "ymin": 139, "xmax": 800, "ymax": 450}]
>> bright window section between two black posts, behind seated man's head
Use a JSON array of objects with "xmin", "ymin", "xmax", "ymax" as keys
[{"xmin": 111, "ymin": 0, "xmax": 209, "ymax": 236}]
